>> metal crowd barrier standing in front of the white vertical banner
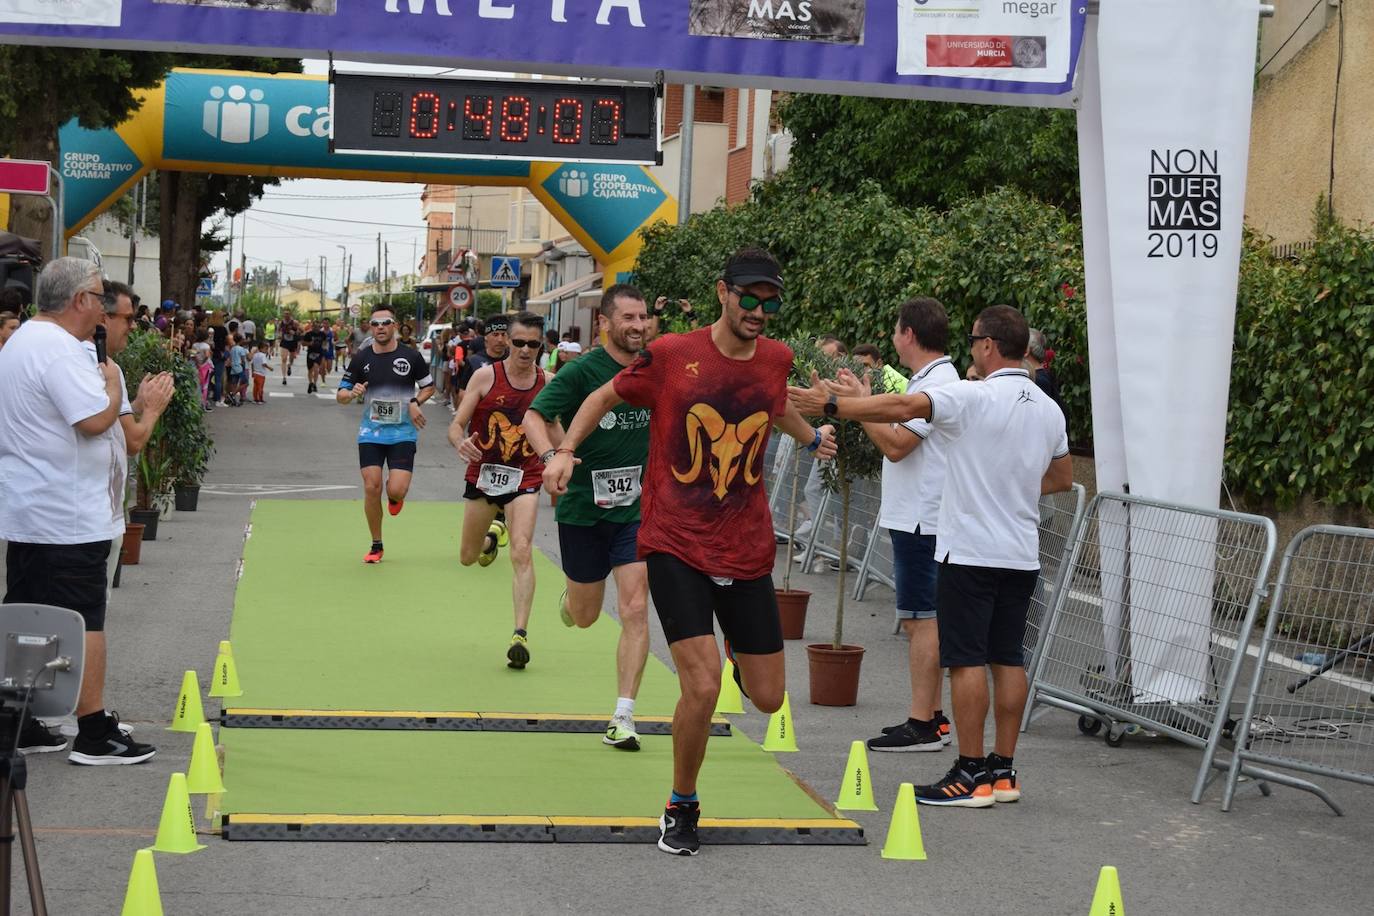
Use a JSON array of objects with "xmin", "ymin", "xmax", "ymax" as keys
[{"xmin": 1028, "ymin": 493, "xmax": 1276, "ymax": 802}]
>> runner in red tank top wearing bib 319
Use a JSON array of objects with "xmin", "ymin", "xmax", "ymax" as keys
[{"xmin": 448, "ymin": 312, "xmax": 547, "ymax": 669}]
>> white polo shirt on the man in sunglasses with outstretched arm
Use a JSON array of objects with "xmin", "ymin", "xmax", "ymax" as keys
[{"xmin": 918, "ymin": 369, "xmax": 1069, "ymax": 570}]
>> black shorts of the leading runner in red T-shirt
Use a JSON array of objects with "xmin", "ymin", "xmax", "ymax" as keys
[{"xmin": 644, "ymin": 553, "xmax": 782, "ymax": 655}]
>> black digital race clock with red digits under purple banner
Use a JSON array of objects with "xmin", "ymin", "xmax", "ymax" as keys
[{"xmin": 330, "ymin": 73, "xmax": 662, "ymax": 165}]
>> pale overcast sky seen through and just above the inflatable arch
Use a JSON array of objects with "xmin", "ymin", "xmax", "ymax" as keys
[{"xmin": 213, "ymin": 60, "xmax": 508, "ymax": 295}]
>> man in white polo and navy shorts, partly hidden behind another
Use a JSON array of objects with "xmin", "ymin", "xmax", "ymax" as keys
[{"xmin": 855, "ymin": 298, "xmax": 959, "ymax": 753}]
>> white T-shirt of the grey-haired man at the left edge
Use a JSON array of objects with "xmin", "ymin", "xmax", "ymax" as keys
[{"xmin": 0, "ymin": 320, "xmax": 114, "ymax": 544}]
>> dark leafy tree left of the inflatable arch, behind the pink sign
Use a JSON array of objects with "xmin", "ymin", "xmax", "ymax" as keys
[{"xmin": 0, "ymin": 45, "xmax": 172, "ymax": 257}]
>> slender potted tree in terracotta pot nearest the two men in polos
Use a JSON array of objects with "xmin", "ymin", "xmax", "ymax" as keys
[{"xmin": 794, "ymin": 345, "xmax": 886, "ymax": 706}]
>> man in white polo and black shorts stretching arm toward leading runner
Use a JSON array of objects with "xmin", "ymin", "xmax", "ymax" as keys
[{"xmin": 789, "ymin": 305, "xmax": 1073, "ymax": 808}]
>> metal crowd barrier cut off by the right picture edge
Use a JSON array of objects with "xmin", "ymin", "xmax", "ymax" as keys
[{"xmin": 1221, "ymin": 525, "xmax": 1374, "ymax": 814}]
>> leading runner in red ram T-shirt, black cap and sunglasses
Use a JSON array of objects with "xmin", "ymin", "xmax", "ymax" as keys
[{"xmin": 544, "ymin": 249, "xmax": 835, "ymax": 856}]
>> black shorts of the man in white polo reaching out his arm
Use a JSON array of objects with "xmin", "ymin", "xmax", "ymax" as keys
[{"xmin": 936, "ymin": 560, "xmax": 1040, "ymax": 667}]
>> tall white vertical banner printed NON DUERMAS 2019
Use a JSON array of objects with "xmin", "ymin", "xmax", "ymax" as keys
[{"xmin": 1084, "ymin": 0, "xmax": 1259, "ymax": 702}]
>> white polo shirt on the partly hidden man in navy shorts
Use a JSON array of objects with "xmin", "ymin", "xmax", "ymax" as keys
[{"xmin": 878, "ymin": 356, "xmax": 959, "ymax": 534}]
